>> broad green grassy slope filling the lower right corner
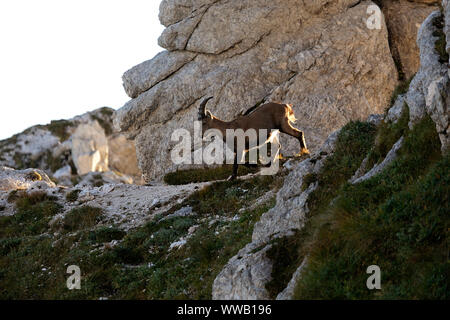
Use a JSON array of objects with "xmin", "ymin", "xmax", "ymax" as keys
[{"xmin": 295, "ymin": 117, "xmax": 450, "ymax": 299}]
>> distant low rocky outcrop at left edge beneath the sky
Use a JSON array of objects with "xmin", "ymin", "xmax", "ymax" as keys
[{"xmin": 0, "ymin": 107, "xmax": 142, "ymax": 186}]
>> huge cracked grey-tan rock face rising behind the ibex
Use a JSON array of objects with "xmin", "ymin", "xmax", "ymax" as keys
[{"xmin": 114, "ymin": 0, "xmax": 397, "ymax": 181}]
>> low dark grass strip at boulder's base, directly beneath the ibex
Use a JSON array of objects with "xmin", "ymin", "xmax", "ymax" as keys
[{"xmin": 164, "ymin": 165, "xmax": 259, "ymax": 185}]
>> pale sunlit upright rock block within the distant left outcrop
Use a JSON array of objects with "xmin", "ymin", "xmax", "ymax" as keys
[{"xmin": 72, "ymin": 121, "xmax": 108, "ymax": 175}]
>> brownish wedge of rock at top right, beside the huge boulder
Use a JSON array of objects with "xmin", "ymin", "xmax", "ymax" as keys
[{"xmin": 383, "ymin": 0, "xmax": 438, "ymax": 79}]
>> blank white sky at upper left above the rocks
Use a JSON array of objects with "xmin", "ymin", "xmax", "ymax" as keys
[{"xmin": 0, "ymin": 0, "xmax": 163, "ymax": 139}]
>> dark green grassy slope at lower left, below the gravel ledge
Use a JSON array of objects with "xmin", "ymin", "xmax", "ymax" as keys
[{"xmin": 0, "ymin": 176, "xmax": 282, "ymax": 299}]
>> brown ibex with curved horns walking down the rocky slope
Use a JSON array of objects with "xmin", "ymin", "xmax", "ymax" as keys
[{"xmin": 198, "ymin": 97, "xmax": 309, "ymax": 179}]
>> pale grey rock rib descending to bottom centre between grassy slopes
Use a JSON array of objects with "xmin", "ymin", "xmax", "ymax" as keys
[{"xmin": 212, "ymin": 132, "xmax": 338, "ymax": 300}]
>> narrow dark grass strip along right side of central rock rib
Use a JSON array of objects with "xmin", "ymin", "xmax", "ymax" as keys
[{"xmin": 266, "ymin": 121, "xmax": 376, "ymax": 298}]
